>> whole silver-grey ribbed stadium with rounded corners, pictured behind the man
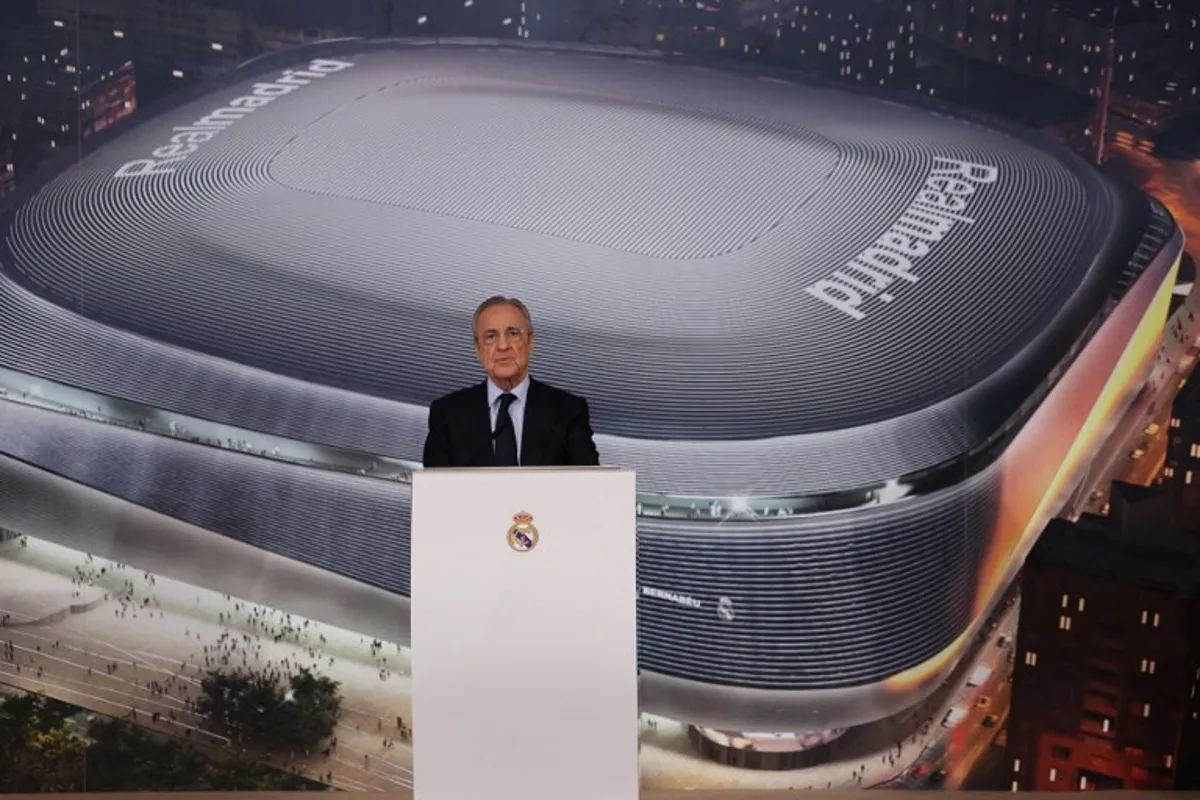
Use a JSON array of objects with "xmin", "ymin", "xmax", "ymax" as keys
[{"xmin": 0, "ymin": 42, "xmax": 1182, "ymax": 732}]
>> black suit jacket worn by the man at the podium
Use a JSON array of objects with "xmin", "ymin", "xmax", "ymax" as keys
[{"xmin": 424, "ymin": 379, "xmax": 600, "ymax": 467}]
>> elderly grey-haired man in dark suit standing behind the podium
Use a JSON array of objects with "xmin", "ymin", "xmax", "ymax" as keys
[{"xmin": 424, "ymin": 296, "xmax": 600, "ymax": 467}]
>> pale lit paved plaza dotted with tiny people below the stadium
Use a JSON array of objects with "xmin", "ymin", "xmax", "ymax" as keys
[{"xmin": 0, "ymin": 539, "xmax": 1017, "ymax": 790}]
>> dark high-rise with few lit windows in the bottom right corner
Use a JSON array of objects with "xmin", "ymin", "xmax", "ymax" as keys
[{"xmin": 1007, "ymin": 491, "xmax": 1200, "ymax": 792}]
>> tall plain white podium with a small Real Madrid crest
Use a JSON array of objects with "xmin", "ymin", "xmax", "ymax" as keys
[{"xmin": 412, "ymin": 468, "xmax": 638, "ymax": 800}]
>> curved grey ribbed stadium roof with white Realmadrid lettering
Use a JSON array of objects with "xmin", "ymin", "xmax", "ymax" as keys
[{"xmin": 0, "ymin": 38, "xmax": 1152, "ymax": 497}]
